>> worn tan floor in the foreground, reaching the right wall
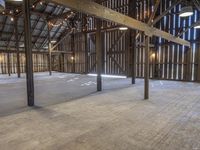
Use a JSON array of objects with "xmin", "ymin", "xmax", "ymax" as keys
[{"xmin": 0, "ymin": 72, "xmax": 200, "ymax": 150}]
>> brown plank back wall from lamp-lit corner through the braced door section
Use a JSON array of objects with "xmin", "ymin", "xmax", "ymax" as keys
[{"xmin": 59, "ymin": 0, "xmax": 129, "ymax": 75}]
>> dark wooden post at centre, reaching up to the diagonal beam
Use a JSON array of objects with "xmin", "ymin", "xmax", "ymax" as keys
[{"xmin": 96, "ymin": 19, "xmax": 102, "ymax": 91}]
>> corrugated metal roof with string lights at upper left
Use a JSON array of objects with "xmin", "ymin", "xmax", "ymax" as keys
[{"xmin": 0, "ymin": 0, "xmax": 74, "ymax": 49}]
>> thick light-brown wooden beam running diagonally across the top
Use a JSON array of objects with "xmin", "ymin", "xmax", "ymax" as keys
[{"xmin": 50, "ymin": 0, "xmax": 190, "ymax": 47}]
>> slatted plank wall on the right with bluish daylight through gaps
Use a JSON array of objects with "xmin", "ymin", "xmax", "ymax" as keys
[{"xmin": 137, "ymin": 0, "xmax": 200, "ymax": 81}]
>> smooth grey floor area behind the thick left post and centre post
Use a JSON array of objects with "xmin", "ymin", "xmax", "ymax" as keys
[{"xmin": 0, "ymin": 72, "xmax": 131, "ymax": 116}]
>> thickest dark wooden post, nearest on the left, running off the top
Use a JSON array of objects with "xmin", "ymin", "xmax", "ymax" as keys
[{"xmin": 23, "ymin": 0, "xmax": 34, "ymax": 106}]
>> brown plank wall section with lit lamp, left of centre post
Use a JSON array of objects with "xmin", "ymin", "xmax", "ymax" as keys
[{"xmin": 57, "ymin": 33, "xmax": 86, "ymax": 73}]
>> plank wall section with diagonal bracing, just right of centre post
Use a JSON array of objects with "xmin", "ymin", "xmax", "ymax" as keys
[{"xmin": 102, "ymin": 0, "xmax": 129, "ymax": 75}]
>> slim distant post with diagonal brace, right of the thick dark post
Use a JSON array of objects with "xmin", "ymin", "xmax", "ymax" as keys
[{"xmin": 47, "ymin": 22, "xmax": 52, "ymax": 76}]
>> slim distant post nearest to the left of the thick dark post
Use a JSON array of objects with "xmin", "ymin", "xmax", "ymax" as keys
[{"xmin": 15, "ymin": 18, "xmax": 21, "ymax": 78}]
